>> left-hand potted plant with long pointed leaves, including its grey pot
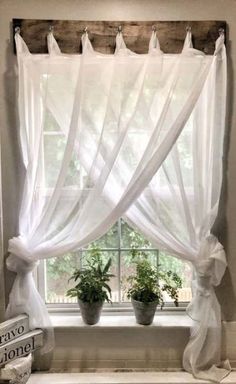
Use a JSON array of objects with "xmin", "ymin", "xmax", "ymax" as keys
[{"xmin": 66, "ymin": 247, "xmax": 114, "ymax": 325}]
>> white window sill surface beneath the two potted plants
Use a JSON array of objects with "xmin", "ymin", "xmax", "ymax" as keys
[{"xmin": 51, "ymin": 312, "xmax": 192, "ymax": 329}]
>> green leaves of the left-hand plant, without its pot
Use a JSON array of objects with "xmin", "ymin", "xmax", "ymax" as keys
[{"xmin": 66, "ymin": 247, "xmax": 114, "ymax": 303}]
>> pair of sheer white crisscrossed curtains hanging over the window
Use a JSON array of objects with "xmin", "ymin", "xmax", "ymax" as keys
[{"xmin": 7, "ymin": 29, "xmax": 226, "ymax": 380}]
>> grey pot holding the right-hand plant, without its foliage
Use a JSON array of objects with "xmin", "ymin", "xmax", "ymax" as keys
[{"xmin": 131, "ymin": 298, "xmax": 158, "ymax": 325}]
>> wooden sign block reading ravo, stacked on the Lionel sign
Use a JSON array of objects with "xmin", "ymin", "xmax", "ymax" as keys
[{"xmin": 0, "ymin": 314, "xmax": 29, "ymax": 347}]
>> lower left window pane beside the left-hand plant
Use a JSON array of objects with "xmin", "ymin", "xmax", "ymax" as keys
[{"xmin": 45, "ymin": 253, "xmax": 79, "ymax": 304}]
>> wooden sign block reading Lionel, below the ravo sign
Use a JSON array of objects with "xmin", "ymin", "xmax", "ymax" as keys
[{"xmin": 0, "ymin": 329, "xmax": 43, "ymax": 367}]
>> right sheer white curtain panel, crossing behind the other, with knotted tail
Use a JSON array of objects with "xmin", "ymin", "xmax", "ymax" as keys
[{"xmin": 123, "ymin": 32, "xmax": 229, "ymax": 382}]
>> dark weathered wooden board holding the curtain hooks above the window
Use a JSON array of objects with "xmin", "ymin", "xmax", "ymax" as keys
[{"xmin": 12, "ymin": 19, "xmax": 226, "ymax": 54}]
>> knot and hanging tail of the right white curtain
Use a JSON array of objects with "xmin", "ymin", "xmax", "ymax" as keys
[{"xmin": 183, "ymin": 235, "xmax": 230, "ymax": 383}]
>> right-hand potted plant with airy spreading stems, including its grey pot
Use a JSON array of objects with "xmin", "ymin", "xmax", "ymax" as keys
[{"xmin": 127, "ymin": 256, "xmax": 182, "ymax": 325}]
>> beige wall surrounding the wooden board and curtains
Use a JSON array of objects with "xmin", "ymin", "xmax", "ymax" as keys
[{"xmin": 0, "ymin": 0, "xmax": 236, "ymax": 320}]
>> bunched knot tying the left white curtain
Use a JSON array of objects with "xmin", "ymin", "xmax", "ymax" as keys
[{"xmin": 6, "ymin": 236, "xmax": 38, "ymax": 274}]
